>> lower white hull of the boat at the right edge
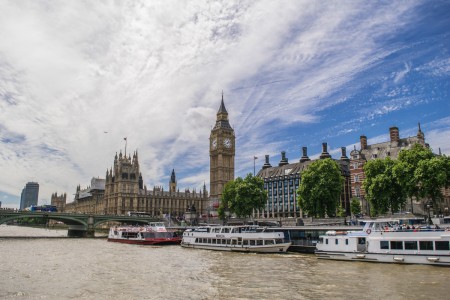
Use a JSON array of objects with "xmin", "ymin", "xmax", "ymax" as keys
[{"xmin": 315, "ymin": 251, "xmax": 450, "ymax": 266}]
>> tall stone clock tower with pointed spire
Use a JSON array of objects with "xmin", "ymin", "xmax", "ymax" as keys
[{"xmin": 209, "ymin": 93, "xmax": 236, "ymax": 199}]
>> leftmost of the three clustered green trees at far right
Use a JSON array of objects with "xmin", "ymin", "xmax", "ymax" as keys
[{"xmin": 363, "ymin": 157, "xmax": 406, "ymax": 216}]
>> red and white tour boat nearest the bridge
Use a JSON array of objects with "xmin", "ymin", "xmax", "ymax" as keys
[{"xmin": 108, "ymin": 222, "xmax": 181, "ymax": 245}]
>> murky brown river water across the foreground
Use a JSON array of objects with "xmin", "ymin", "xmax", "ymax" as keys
[{"xmin": 0, "ymin": 225, "xmax": 450, "ymax": 299}]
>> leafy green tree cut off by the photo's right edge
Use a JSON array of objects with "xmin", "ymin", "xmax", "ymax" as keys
[{"xmin": 414, "ymin": 157, "xmax": 450, "ymax": 211}]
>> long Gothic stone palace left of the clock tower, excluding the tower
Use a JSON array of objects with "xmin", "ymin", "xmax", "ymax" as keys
[{"xmin": 66, "ymin": 151, "xmax": 208, "ymax": 217}]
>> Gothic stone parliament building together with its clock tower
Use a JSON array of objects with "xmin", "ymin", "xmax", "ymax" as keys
[{"xmin": 51, "ymin": 95, "xmax": 235, "ymax": 218}]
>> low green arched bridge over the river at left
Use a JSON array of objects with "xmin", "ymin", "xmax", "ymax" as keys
[{"xmin": 0, "ymin": 209, "xmax": 160, "ymax": 237}]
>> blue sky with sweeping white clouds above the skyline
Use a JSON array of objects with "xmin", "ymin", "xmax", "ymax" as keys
[{"xmin": 0, "ymin": 0, "xmax": 450, "ymax": 208}]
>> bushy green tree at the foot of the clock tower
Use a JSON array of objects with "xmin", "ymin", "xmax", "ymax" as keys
[{"xmin": 218, "ymin": 173, "xmax": 267, "ymax": 219}]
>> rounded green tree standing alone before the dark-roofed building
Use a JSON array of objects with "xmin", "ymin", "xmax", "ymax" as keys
[{"xmin": 297, "ymin": 158, "xmax": 344, "ymax": 217}]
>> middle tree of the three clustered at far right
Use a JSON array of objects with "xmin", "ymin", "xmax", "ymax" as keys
[{"xmin": 393, "ymin": 144, "xmax": 434, "ymax": 213}]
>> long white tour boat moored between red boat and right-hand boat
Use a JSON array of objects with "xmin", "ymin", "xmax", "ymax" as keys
[{"xmin": 181, "ymin": 225, "xmax": 291, "ymax": 253}]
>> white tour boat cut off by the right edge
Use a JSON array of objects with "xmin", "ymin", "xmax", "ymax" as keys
[{"xmin": 315, "ymin": 219, "xmax": 450, "ymax": 266}]
